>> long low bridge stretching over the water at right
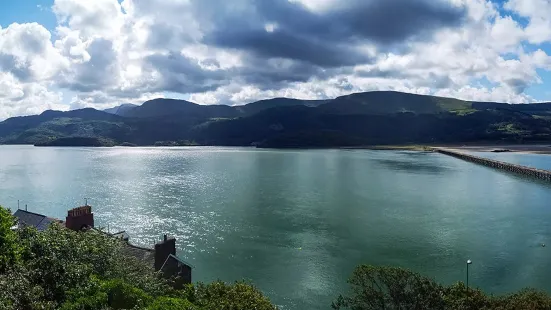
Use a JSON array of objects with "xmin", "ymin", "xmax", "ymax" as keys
[{"xmin": 434, "ymin": 148, "xmax": 551, "ymax": 182}]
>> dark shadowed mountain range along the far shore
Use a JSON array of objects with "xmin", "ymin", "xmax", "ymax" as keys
[{"xmin": 0, "ymin": 91, "xmax": 551, "ymax": 147}]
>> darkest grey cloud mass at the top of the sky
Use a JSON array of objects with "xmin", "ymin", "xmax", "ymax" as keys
[{"xmin": 194, "ymin": 0, "xmax": 466, "ymax": 67}]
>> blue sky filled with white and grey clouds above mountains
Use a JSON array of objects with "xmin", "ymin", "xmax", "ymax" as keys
[{"xmin": 0, "ymin": 0, "xmax": 551, "ymax": 120}]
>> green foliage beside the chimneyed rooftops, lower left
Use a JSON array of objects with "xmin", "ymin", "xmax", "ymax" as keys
[{"xmin": 0, "ymin": 207, "xmax": 275, "ymax": 310}]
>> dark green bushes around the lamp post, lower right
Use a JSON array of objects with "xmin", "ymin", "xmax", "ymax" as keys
[{"xmin": 332, "ymin": 265, "xmax": 551, "ymax": 310}]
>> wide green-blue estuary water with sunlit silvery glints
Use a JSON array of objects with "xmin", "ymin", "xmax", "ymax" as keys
[{"xmin": 0, "ymin": 146, "xmax": 551, "ymax": 309}]
